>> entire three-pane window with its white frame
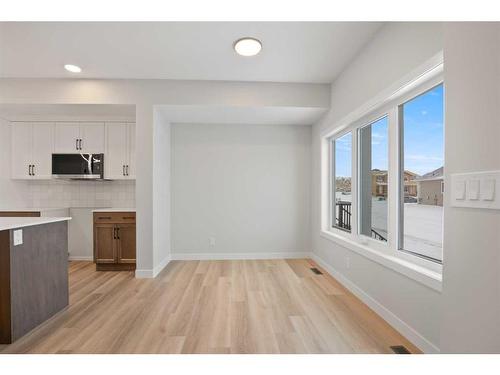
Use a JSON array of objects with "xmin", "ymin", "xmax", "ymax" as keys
[{"xmin": 321, "ymin": 65, "xmax": 448, "ymax": 276}]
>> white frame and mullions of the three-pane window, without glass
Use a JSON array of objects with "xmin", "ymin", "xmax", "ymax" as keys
[{"xmin": 320, "ymin": 68, "xmax": 446, "ymax": 280}]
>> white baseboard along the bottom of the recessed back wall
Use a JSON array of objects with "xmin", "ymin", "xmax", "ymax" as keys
[{"xmin": 172, "ymin": 251, "xmax": 311, "ymax": 260}]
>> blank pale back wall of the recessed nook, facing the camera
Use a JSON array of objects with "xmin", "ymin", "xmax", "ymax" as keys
[{"xmin": 172, "ymin": 124, "xmax": 311, "ymax": 258}]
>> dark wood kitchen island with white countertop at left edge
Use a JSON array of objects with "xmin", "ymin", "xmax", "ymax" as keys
[{"xmin": 0, "ymin": 217, "xmax": 71, "ymax": 344}]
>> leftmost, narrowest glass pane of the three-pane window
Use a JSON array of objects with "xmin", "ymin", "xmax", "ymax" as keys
[{"xmin": 332, "ymin": 133, "xmax": 352, "ymax": 232}]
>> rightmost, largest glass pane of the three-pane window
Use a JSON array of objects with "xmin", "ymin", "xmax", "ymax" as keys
[{"xmin": 399, "ymin": 84, "xmax": 444, "ymax": 261}]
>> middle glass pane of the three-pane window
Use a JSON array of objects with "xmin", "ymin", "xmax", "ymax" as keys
[{"xmin": 358, "ymin": 116, "xmax": 389, "ymax": 242}]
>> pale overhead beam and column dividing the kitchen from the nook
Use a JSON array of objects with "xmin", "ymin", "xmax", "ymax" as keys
[{"xmin": 0, "ymin": 79, "xmax": 330, "ymax": 275}]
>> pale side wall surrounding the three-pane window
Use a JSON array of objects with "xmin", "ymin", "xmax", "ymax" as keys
[{"xmin": 312, "ymin": 23, "xmax": 443, "ymax": 352}]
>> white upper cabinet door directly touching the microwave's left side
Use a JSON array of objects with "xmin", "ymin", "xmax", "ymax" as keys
[{"xmin": 32, "ymin": 122, "xmax": 54, "ymax": 179}]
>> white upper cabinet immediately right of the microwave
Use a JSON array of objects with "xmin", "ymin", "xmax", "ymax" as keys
[{"xmin": 104, "ymin": 122, "xmax": 135, "ymax": 180}]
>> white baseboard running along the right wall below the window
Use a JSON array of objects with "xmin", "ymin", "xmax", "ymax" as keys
[{"xmin": 312, "ymin": 254, "xmax": 440, "ymax": 353}]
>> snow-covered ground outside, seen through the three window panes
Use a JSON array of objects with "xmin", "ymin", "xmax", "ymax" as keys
[{"xmin": 336, "ymin": 192, "xmax": 443, "ymax": 260}]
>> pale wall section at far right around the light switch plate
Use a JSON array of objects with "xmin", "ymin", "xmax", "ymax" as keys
[{"xmin": 441, "ymin": 23, "xmax": 500, "ymax": 353}]
